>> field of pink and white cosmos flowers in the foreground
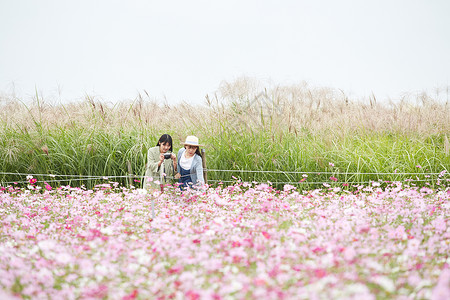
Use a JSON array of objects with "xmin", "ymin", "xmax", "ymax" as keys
[{"xmin": 0, "ymin": 182, "xmax": 450, "ymax": 299}]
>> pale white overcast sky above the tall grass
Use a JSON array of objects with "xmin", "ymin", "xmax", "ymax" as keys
[{"xmin": 0, "ymin": 0, "xmax": 450, "ymax": 103}]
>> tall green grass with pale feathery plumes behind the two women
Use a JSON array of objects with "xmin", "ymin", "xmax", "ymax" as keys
[{"xmin": 0, "ymin": 78, "xmax": 450, "ymax": 189}]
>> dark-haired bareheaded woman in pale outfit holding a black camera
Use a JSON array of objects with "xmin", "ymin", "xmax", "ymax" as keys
[{"xmin": 144, "ymin": 134, "xmax": 177, "ymax": 191}]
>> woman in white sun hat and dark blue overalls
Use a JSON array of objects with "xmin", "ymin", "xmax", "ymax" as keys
[{"xmin": 175, "ymin": 135, "xmax": 205, "ymax": 189}]
